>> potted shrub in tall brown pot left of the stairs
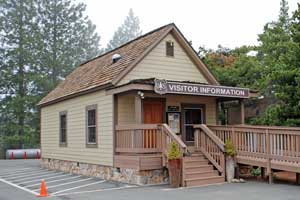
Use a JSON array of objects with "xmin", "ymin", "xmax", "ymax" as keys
[{"xmin": 168, "ymin": 141, "xmax": 181, "ymax": 187}]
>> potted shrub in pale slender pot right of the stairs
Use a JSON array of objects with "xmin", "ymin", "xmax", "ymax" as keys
[{"xmin": 225, "ymin": 139, "xmax": 236, "ymax": 183}]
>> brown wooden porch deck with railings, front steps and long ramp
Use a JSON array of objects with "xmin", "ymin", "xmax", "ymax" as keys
[{"xmin": 114, "ymin": 124, "xmax": 300, "ymax": 185}]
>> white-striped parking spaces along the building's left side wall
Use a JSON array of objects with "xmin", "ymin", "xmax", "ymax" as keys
[{"xmin": 0, "ymin": 160, "xmax": 137, "ymax": 200}]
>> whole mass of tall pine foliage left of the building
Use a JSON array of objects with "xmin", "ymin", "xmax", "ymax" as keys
[{"xmin": 0, "ymin": 0, "xmax": 100, "ymax": 148}]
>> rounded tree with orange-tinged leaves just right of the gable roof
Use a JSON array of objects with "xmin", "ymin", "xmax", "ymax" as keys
[{"xmin": 199, "ymin": 45, "xmax": 261, "ymax": 89}]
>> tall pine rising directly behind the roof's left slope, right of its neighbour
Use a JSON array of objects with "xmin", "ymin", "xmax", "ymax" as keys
[{"xmin": 37, "ymin": 0, "xmax": 101, "ymax": 94}]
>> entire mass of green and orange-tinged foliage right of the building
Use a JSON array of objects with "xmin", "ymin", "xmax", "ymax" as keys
[{"xmin": 199, "ymin": 0, "xmax": 300, "ymax": 126}]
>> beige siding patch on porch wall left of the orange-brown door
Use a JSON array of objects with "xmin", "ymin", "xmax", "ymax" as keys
[{"xmin": 118, "ymin": 94, "xmax": 135, "ymax": 124}]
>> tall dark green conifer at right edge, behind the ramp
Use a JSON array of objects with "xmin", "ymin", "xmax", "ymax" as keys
[{"xmin": 252, "ymin": 0, "xmax": 300, "ymax": 126}]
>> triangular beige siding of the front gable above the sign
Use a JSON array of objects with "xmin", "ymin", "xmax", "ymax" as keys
[{"xmin": 119, "ymin": 34, "xmax": 207, "ymax": 85}]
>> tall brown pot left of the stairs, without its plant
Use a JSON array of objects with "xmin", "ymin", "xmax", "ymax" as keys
[{"xmin": 168, "ymin": 159, "xmax": 181, "ymax": 187}]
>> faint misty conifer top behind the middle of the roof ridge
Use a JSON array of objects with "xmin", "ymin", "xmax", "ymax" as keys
[{"xmin": 106, "ymin": 9, "xmax": 142, "ymax": 51}]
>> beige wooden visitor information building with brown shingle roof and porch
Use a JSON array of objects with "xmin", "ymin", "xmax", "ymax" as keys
[{"xmin": 39, "ymin": 24, "xmax": 300, "ymax": 186}]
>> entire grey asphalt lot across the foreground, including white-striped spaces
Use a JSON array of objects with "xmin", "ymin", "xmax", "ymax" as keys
[{"xmin": 0, "ymin": 160, "xmax": 300, "ymax": 200}]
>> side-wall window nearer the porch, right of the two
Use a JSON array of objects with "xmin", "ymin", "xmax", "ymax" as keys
[{"xmin": 86, "ymin": 105, "xmax": 97, "ymax": 147}]
